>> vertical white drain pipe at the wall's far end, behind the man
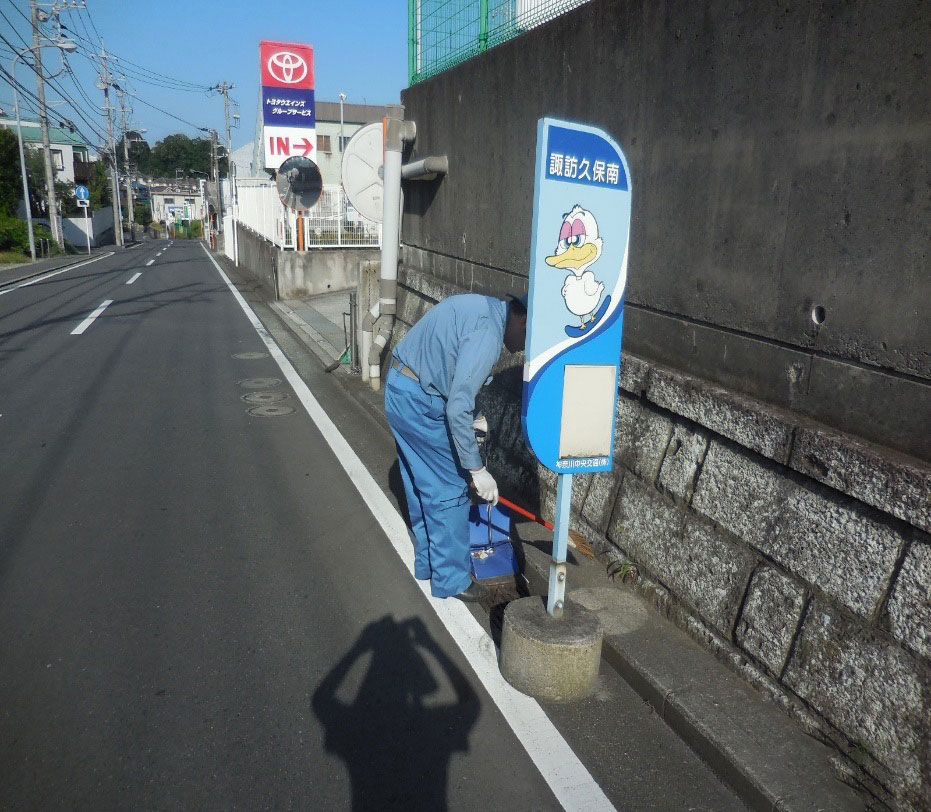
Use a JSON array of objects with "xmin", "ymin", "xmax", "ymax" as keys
[{"xmin": 362, "ymin": 104, "xmax": 416, "ymax": 391}]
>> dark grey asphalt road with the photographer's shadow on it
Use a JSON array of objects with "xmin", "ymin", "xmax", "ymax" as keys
[{"xmin": 0, "ymin": 241, "xmax": 739, "ymax": 811}]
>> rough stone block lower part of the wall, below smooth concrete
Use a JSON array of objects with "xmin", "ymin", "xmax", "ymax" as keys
[{"xmin": 395, "ymin": 246, "xmax": 931, "ymax": 810}]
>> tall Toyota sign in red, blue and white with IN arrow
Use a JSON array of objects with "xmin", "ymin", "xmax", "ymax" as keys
[{"xmin": 259, "ymin": 40, "xmax": 317, "ymax": 169}]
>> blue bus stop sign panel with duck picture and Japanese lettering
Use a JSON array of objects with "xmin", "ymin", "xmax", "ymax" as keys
[{"xmin": 523, "ymin": 118, "xmax": 631, "ymax": 474}]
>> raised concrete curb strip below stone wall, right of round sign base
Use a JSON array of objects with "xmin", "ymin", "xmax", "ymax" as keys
[{"xmin": 524, "ymin": 544, "xmax": 867, "ymax": 812}]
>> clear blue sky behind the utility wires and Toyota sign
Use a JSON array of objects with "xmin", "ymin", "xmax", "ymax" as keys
[{"xmin": 0, "ymin": 0, "xmax": 407, "ymax": 149}]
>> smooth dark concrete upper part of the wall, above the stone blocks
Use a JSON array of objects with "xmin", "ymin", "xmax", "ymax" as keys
[{"xmin": 402, "ymin": 0, "xmax": 931, "ymax": 460}]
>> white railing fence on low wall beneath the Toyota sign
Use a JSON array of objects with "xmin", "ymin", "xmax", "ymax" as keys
[{"xmin": 235, "ymin": 178, "xmax": 381, "ymax": 249}]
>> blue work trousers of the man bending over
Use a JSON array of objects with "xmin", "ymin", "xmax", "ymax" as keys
[{"xmin": 385, "ymin": 369, "xmax": 471, "ymax": 598}]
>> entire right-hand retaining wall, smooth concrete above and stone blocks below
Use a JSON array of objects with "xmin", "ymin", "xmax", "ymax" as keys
[{"xmin": 395, "ymin": 0, "xmax": 931, "ymax": 810}]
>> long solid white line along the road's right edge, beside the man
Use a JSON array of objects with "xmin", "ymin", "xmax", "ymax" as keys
[{"xmin": 201, "ymin": 243, "xmax": 616, "ymax": 812}]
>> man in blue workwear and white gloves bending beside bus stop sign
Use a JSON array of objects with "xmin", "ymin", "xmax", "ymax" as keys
[{"xmin": 385, "ymin": 293, "xmax": 527, "ymax": 601}]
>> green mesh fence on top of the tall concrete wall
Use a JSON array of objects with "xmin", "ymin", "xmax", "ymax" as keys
[{"xmin": 407, "ymin": 0, "xmax": 588, "ymax": 84}]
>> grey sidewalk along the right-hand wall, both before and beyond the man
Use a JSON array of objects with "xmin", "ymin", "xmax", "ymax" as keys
[{"xmin": 255, "ymin": 278, "xmax": 878, "ymax": 812}]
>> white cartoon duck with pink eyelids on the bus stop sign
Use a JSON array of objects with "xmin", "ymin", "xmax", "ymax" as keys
[{"xmin": 546, "ymin": 204, "xmax": 604, "ymax": 330}]
